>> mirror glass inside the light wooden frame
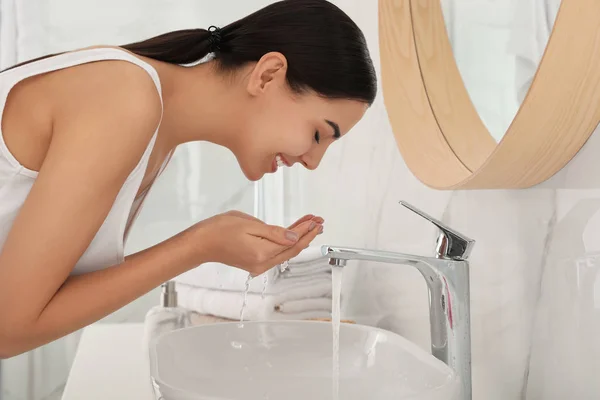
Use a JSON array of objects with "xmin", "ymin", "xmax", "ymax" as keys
[{"xmin": 441, "ymin": 0, "xmax": 561, "ymax": 142}]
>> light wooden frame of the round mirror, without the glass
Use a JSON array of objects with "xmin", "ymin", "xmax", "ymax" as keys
[{"xmin": 379, "ymin": 0, "xmax": 600, "ymax": 190}]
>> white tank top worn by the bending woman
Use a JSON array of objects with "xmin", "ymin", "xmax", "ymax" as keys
[{"xmin": 0, "ymin": 47, "xmax": 164, "ymax": 275}]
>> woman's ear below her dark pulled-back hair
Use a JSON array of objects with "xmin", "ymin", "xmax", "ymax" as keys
[{"xmin": 247, "ymin": 52, "xmax": 287, "ymax": 96}]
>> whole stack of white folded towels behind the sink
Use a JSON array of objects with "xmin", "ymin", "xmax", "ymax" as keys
[{"xmin": 175, "ymin": 246, "xmax": 332, "ymax": 321}]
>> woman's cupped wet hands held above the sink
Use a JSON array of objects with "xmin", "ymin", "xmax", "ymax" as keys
[{"xmin": 181, "ymin": 211, "xmax": 324, "ymax": 275}]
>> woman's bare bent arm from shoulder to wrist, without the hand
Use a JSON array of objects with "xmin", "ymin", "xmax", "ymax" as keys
[{"xmin": 0, "ymin": 61, "xmax": 164, "ymax": 358}]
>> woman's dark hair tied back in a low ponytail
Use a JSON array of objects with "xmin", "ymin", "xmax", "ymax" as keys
[{"xmin": 121, "ymin": 0, "xmax": 377, "ymax": 105}]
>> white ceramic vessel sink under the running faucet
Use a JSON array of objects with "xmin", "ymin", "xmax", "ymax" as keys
[{"xmin": 150, "ymin": 321, "xmax": 460, "ymax": 400}]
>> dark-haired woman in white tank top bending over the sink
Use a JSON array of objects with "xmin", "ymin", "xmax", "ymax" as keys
[{"xmin": 0, "ymin": 0, "xmax": 376, "ymax": 358}]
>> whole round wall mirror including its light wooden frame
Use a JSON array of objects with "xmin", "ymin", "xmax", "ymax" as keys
[{"xmin": 379, "ymin": 0, "xmax": 600, "ymax": 190}]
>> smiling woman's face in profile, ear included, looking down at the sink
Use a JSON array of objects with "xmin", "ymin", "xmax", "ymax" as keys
[{"xmin": 232, "ymin": 54, "xmax": 368, "ymax": 181}]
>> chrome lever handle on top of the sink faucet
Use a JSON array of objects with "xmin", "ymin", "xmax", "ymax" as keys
[{"xmin": 400, "ymin": 200, "xmax": 475, "ymax": 260}]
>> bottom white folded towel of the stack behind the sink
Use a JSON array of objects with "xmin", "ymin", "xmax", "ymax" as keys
[{"xmin": 177, "ymin": 282, "xmax": 331, "ymax": 321}]
